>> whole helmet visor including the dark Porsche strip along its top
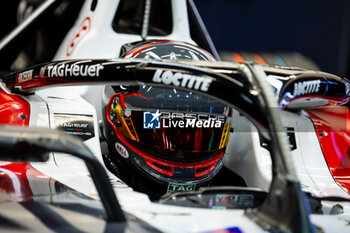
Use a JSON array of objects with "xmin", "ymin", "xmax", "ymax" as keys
[{"xmin": 116, "ymin": 86, "xmax": 229, "ymax": 162}]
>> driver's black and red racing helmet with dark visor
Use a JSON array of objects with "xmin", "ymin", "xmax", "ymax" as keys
[{"xmin": 104, "ymin": 41, "xmax": 231, "ymax": 195}]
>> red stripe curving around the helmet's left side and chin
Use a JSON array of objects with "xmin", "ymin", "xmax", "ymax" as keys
[{"xmin": 106, "ymin": 93, "xmax": 224, "ymax": 177}]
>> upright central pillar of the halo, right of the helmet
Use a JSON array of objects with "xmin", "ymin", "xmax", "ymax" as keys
[{"xmin": 246, "ymin": 63, "xmax": 315, "ymax": 233}]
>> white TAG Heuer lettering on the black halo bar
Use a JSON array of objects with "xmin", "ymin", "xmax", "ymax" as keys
[{"xmin": 47, "ymin": 64, "xmax": 104, "ymax": 77}]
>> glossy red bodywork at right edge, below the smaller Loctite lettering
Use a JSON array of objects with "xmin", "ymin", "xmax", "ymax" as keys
[{"xmin": 307, "ymin": 106, "xmax": 350, "ymax": 194}]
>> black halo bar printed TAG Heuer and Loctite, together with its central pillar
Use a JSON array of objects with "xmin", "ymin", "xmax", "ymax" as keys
[{"xmin": 3, "ymin": 59, "xmax": 349, "ymax": 232}]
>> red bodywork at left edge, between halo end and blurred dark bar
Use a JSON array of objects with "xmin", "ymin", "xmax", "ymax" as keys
[{"xmin": 0, "ymin": 88, "xmax": 30, "ymax": 126}]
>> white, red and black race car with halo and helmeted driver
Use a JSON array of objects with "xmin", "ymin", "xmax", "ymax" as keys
[{"xmin": 0, "ymin": 1, "xmax": 349, "ymax": 232}]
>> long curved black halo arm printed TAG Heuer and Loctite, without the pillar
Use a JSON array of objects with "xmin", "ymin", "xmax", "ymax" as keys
[{"xmin": 2, "ymin": 59, "xmax": 267, "ymax": 132}]
